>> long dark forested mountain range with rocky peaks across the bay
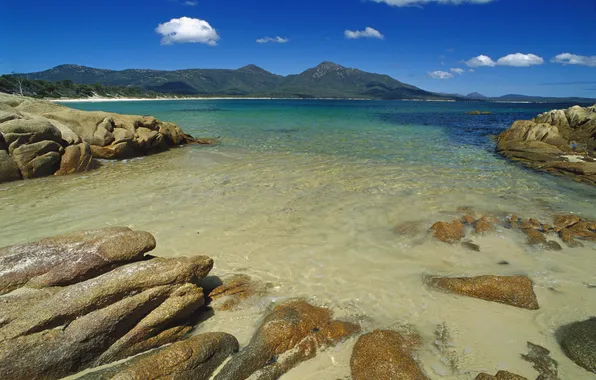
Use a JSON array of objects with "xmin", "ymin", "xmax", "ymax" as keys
[{"xmin": 17, "ymin": 62, "xmax": 453, "ymax": 99}]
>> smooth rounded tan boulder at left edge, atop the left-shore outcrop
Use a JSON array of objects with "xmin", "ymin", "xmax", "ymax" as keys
[{"xmin": 0, "ymin": 119, "xmax": 62, "ymax": 149}]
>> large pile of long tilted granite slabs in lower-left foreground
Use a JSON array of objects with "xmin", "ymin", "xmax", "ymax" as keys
[{"xmin": 0, "ymin": 227, "xmax": 213, "ymax": 380}]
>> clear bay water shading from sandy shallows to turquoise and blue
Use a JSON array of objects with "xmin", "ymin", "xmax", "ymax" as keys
[{"xmin": 0, "ymin": 100, "xmax": 596, "ymax": 379}]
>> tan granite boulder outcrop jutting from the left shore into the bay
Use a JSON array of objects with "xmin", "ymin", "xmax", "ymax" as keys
[{"xmin": 0, "ymin": 94, "xmax": 213, "ymax": 183}]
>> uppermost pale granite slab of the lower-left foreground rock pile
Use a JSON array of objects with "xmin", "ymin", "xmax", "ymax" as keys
[{"xmin": 0, "ymin": 227, "xmax": 155, "ymax": 294}]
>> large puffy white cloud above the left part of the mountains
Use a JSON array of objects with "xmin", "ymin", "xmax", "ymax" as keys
[{"xmin": 155, "ymin": 17, "xmax": 219, "ymax": 46}]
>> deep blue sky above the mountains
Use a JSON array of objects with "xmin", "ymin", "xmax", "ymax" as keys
[{"xmin": 0, "ymin": 0, "xmax": 596, "ymax": 97}]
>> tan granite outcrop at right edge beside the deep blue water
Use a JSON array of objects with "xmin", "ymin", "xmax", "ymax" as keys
[{"xmin": 497, "ymin": 105, "xmax": 596, "ymax": 185}]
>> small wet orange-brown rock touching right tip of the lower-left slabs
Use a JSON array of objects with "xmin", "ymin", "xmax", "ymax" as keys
[{"xmin": 209, "ymin": 274, "xmax": 264, "ymax": 311}]
